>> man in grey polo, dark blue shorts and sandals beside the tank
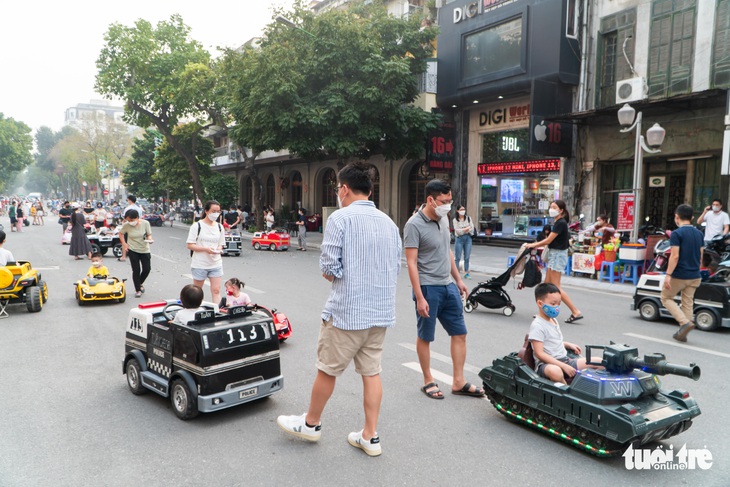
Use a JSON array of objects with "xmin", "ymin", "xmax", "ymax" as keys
[{"xmin": 403, "ymin": 179, "xmax": 484, "ymax": 399}]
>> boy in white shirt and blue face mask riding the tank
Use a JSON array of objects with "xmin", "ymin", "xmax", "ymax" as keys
[{"xmin": 528, "ymin": 282, "xmax": 591, "ymax": 384}]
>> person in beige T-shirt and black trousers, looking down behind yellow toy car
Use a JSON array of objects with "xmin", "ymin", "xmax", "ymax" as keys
[{"xmin": 119, "ymin": 209, "xmax": 154, "ymax": 298}]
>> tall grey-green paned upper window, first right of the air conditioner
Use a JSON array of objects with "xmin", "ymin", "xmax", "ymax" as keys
[{"xmin": 648, "ymin": 0, "xmax": 697, "ymax": 98}]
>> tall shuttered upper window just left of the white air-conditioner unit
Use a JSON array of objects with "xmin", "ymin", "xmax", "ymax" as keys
[{"xmin": 596, "ymin": 9, "xmax": 636, "ymax": 107}]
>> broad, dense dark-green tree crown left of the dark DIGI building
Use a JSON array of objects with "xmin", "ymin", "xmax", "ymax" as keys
[{"xmin": 222, "ymin": 4, "xmax": 438, "ymax": 159}]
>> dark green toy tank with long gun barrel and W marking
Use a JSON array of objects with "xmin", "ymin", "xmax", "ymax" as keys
[{"xmin": 479, "ymin": 343, "xmax": 700, "ymax": 457}]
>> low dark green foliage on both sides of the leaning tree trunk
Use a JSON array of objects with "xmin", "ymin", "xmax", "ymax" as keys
[{"xmin": 154, "ymin": 124, "xmax": 215, "ymax": 199}]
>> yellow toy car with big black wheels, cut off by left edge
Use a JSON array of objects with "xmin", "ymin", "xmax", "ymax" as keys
[{"xmin": 0, "ymin": 261, "xmax": 48, "ymax": 318}]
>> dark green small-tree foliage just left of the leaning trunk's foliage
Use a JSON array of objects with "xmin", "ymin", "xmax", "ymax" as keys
[{"xmin": 122, "ymin": 129, "xmax": 162, "ymax": 200}]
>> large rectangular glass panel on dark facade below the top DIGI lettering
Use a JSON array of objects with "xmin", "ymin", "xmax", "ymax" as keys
[{"xmin": 462, "ymin": 16, "xmax": 524, "ymax": 84}]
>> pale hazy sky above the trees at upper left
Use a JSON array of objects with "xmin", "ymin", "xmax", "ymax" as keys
[{"xmin": 0, "ymin": 0, "xmax": 294, "ymax": 131}]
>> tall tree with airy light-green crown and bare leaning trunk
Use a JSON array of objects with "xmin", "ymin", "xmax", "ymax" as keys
[{"xmin": 95, "ymin": 15, "xmax": 210, "ymax": 204}]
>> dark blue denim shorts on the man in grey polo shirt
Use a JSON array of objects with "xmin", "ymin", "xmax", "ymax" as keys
[{"xmin": 413, "ymin": 282, "xmax": 466, "ymax": 342}]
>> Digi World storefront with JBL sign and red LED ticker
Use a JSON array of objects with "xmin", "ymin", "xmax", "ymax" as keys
[{"xmin": 467, "ymin": 99, "xmax": 561, "ymax": 237}]
